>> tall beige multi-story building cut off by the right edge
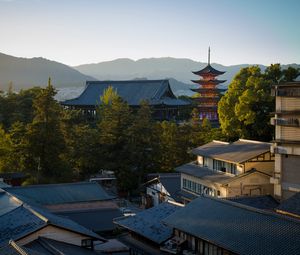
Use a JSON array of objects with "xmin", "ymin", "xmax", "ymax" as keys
[{"xmin": 271, "ymin": 82, "xmax": 300, "ymax": 200}]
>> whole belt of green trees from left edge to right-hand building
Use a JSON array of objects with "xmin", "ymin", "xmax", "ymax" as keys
[{"xmin": 0, "ymin": 64, "xmax": 299, "ymax": 191}]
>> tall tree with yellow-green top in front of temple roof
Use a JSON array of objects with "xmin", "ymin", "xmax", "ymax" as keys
[{"xmin": 97, "ymin": 87, "xmax": 134, "ymax": 190}]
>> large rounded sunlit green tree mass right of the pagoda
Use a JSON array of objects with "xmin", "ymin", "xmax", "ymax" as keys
[{"xmin": 218, "ymin": 64, "xmax": 300, "ymax": 141}]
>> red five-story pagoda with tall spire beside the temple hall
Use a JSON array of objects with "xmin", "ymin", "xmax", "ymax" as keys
[{"xmin": 191, "ymin": 48, "xmax": 226, "ymax": 125}]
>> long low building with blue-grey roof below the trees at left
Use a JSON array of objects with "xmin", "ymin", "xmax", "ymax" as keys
[{"xmin": 5, "ymin": 182, "xmax": 122, "ymax": 232}]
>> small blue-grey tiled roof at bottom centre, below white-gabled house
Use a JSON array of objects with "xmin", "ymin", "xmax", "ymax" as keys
[{"xmin": 114, "ymin": 202, "xmax": 182, "ymax": 244}]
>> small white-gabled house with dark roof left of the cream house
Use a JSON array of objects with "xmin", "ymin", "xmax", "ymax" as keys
[{"xmin": 143, "ymin": 173, "xmax": 181, "ymax": 208}]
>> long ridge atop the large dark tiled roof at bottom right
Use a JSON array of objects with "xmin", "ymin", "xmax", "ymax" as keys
[{"xmin": 207, "ymin": 195, "xmax": 300, "ymax": 224}]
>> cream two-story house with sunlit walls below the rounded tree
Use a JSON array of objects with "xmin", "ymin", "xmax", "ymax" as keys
[{"xmin": 176, "ymin": 139, "xmax": 274, "ymax": 201}]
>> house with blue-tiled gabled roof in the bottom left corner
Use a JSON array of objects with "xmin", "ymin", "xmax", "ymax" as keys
[{"xmin": 0, "ymin": 190, "xmax": 128, "ymax": 255}]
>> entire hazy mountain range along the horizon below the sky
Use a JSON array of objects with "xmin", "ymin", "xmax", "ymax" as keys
[{"xmin": 0, "ymin": 53, "xmax": 300, "ymax": 96}]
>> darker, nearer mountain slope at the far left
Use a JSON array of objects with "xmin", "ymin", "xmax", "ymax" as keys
[{"xmin": 0, "ymin": 53, "xmax": 95, "ymax": 90}]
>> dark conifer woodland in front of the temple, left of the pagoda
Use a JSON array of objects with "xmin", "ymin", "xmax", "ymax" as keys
[{"xmin": 0, "ymin": 80, "xmax": 222, "ymax": 191}]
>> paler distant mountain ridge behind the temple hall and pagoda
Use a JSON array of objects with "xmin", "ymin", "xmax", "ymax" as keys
[{"xmin": 74, "ymin": 57, "xmax": 252, "ymax": 87}]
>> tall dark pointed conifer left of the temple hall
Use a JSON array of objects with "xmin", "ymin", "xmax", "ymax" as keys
[{"xmin": 26, "ymin": 78, "xmax": 69, "ymax": 183}]
